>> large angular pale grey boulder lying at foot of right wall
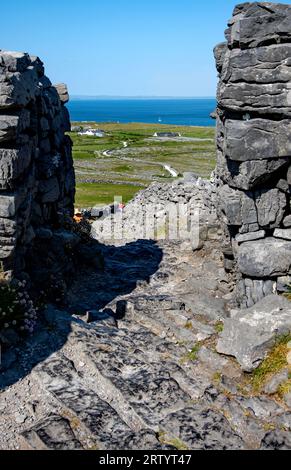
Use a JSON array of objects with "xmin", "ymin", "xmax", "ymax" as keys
[{"xmin": 216, "ymin": 295, "xmax": 291, "ymax": 372}]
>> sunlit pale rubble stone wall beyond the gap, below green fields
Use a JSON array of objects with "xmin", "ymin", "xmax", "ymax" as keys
[{"xmin": 91, "ymin": 175, "xmax": 220, "ymax": 249}]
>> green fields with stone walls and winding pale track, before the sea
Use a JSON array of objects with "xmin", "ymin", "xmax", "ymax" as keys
[{"xmin": 70, "ymin": 123, "xmax": 216, "ymax": 208}]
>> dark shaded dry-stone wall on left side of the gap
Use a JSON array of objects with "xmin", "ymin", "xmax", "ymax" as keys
[{"xmin": 0, "ymin": 51, "xmax": 75, "ymax": 278}]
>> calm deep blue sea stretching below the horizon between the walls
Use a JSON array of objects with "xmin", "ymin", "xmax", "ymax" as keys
[{"xmin": 68, "ymin": 98, "xmax": 216, "ymax": 126}]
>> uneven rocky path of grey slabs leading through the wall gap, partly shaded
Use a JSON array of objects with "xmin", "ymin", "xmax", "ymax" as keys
[{"xmin": 0, "ymin": 237, "xmax": 291, "ymax": 450}]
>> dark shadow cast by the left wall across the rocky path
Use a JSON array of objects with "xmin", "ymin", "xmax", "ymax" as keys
[{"xmin": 0, "ymin": 240, "xmax": 163, "ymax": 390}]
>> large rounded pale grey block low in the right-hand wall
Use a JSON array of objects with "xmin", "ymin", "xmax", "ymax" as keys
[{"xmin": 238, "ymin": 237, "xmax": 291, "ymax": 279}]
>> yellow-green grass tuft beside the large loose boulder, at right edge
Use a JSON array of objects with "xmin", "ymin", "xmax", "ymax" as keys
[{"xmin": 251, "ymin": 334, "xmax": 291, "ymax": 392}]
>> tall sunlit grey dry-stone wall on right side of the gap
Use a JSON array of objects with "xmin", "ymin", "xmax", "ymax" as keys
[{"xmin": 215, "ymin": 3, "xmax": 291, "ymax": 307}]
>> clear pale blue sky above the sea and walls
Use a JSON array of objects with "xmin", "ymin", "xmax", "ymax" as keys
[{"xmin": 0, "ymin": 0, "xmax": 289, "ymax": 96}]
